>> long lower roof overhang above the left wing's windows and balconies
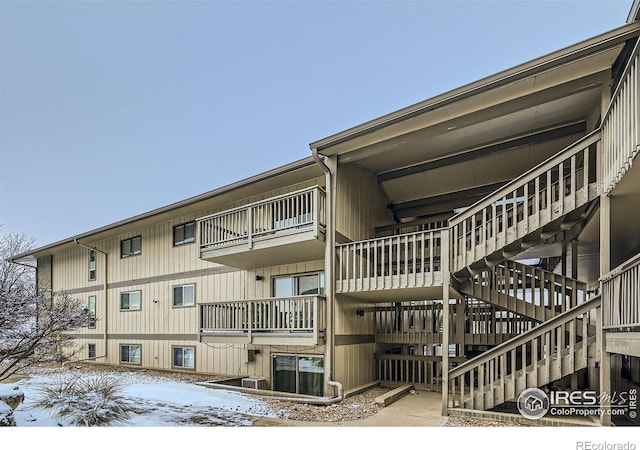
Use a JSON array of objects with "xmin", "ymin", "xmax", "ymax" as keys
[{"xmin": 9, "ymin": 157, "xmax": 324, "ymax": 262}]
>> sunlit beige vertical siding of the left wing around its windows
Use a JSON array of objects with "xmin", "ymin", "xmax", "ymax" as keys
[{"xmin": 50, "ymin": 178, "xmax": 324, "ymax": 383}]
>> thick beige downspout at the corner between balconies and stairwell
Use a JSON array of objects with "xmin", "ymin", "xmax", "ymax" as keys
[{"xmin": 311, "ymin": 147, "xmax": 344, "ymax": 403}]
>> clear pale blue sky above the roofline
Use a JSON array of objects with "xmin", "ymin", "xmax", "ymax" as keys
[{"xmin": 0, "ymin": 0, "xmax": 632, "ymax": 245}]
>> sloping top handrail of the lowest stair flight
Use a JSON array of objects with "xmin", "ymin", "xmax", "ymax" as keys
[{"xmin": 449, "ymin": 297, "xmax": 601, "ymax": 378}]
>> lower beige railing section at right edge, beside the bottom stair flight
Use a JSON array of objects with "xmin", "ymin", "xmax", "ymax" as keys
[{"xmin": 601, "ymin": 254, "xmax": 640, "ymax": 328}]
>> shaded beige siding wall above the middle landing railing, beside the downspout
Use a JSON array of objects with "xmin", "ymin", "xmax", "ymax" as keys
[{"xmin": 336, "ymin": 164, "xmax": 392, "ymax": 241}]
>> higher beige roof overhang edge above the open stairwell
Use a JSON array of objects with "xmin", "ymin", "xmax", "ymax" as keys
[{"xmin": 310, "ymin": 22, "xmax": 640, "ymax": 162}]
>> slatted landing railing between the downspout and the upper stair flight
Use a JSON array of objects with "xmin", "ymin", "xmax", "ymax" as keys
[{"xmin": 336, "ymin": 230, "xmax": 441, "ymax": 293}]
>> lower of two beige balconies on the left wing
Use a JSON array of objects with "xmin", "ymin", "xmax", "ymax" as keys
[{"xmin": 200, "ymin": 295, "xmax": 325, "ymax": 345}]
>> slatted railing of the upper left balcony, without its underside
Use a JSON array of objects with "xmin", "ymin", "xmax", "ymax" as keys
[{"xmin": 198, "ymin": 186, "xmax": 325, "ymax": 250}]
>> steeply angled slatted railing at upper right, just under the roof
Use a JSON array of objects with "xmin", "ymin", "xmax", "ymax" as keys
[{"xmin": 602, "ymin": 37, "xmax": 640, "ymax": 194}]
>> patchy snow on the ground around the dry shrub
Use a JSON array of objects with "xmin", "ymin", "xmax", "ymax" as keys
[{"xmin": 7, "ymin": 370, "xmax": 276, "ymax": 427}]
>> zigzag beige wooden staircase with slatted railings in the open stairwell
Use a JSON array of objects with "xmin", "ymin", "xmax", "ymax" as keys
[{"xmin": 448, "ymin": 130, "xmax": 601, "ymax": 410}]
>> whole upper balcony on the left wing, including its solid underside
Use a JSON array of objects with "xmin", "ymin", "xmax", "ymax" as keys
[{"xmin": 198, "ymin": 186, "xmax": 325, "ymax": 269}]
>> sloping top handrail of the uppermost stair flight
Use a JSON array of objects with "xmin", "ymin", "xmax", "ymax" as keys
[{"xmin": 449, "ymin": 128, "xmax": 600, "ymax": 228}]
